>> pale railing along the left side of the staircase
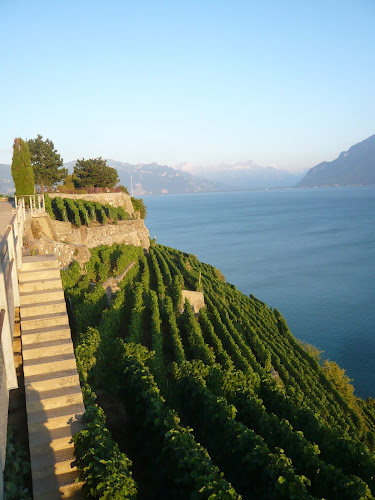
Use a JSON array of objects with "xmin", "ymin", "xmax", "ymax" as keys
[{"xmin": 0, "ymin": 203, "xmax": 25, "ymax": 390}]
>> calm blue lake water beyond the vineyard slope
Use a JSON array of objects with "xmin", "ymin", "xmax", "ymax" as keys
[{"xmin": 145, "ymin": 187, "xmax": 375, "ymax": 398}]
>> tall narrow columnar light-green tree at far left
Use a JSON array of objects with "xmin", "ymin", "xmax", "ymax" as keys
[{"xmin": 11, "ymin": 137, "xmax": 35, "ymax": 196}]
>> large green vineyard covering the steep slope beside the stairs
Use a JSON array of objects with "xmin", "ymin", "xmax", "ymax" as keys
[{"xmin": 61, "ymin": 243, "xmax": 375, "ymax": 499}]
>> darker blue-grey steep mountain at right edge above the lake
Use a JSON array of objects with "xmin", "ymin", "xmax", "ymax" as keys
[{"xmin": 297, "ymin": 135, "xmax": 375, "ymax": 187}]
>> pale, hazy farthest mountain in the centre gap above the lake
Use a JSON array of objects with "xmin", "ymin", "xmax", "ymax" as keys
[{"xmin": 176, "ymin": 160, "xmax": 306, "ymax": 189}]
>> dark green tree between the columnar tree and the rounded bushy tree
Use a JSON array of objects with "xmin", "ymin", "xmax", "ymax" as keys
[{"xmin": 28, "ymin": 134, "xmax": 68, "ymax": 193}]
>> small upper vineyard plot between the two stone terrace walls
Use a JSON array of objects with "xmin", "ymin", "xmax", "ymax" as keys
[{"xmin": 44, "ymin": 194, "xmax": 146, "ymax": 227}]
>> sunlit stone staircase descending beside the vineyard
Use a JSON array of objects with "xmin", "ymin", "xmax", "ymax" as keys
[{"xmin": 19, "ymin": 255, "xmax": 85, "ymax": 500}]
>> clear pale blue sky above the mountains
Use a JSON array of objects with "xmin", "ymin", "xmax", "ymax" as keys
[{"xmin": 0, "ymin": 0, "xmax": 375, "ymax": 170}]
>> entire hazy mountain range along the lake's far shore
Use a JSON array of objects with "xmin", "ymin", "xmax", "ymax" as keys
[{"xmin": 0, "ymin": 135, "xmax": 375, "ymax": 196}]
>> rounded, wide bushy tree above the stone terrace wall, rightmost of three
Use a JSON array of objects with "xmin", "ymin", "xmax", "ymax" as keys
[{"xmin": 74, "ymin": 157, "xmax": 119, "ymax": 187}]
